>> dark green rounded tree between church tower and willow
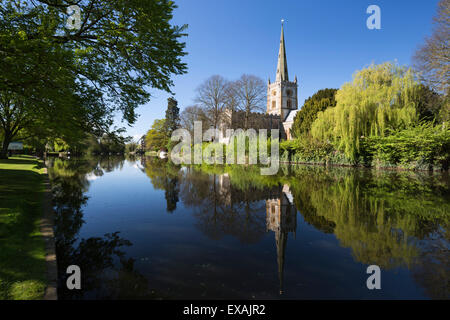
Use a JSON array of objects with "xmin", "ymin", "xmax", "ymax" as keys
[{"xmin": 292, "ymin": 89, "xmax": 337, "ymax": 138}]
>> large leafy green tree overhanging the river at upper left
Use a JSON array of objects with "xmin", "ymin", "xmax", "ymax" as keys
[{"xmin": 0, "ymin": 0, "xmax": 186, "ymax": 157}]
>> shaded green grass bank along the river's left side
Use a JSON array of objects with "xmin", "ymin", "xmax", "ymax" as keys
[{"xmin": 0, "ymin": 156, "xmax": 46, "ymax": 300}]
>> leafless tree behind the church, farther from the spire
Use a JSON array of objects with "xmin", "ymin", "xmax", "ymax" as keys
[{"xmin": 195, "ymin": 75, "xmax": 229, "ymax": 128}]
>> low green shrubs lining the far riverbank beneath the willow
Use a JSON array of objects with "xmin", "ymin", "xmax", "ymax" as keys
[{"xmin": 280, "ymin": 123, "xmax": 450, "ymax": 170}]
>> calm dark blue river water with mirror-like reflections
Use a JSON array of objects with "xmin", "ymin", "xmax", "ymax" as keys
[{"xmin": 48, "ymin": 158, "xmax": 450, "ymax": 299}]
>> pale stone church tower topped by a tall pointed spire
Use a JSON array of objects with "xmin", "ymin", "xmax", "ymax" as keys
[{"xmin": 267, "ymin": 24, "xmax": 298, "ymax": 122}]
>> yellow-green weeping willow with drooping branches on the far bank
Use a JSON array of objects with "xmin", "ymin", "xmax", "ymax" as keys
[{"xmin": 311, "ymin": 62, "xmax": 418, "ymax": 161}]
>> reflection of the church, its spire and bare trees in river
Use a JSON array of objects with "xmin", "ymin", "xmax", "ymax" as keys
[{"xmin": 143, "ymin": 159, "xmax": 297, "ymax": 294}]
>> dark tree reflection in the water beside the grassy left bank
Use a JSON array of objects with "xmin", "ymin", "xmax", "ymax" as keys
[{"xmin": 47, "ymin": 157, "xmax": 163, "ymax": 299}]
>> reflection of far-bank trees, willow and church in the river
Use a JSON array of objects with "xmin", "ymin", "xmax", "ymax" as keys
[{"xmin": 146, "ymin": 159, "xmax": 450, "ymax": 298}]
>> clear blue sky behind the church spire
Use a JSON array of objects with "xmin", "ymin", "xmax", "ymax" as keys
[{"xmin": 117, "ymin": 0, "xmax": 438, "ymax": 141}]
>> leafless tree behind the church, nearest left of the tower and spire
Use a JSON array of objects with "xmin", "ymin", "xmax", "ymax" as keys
[{"xmin": 232, "ymin": 74, "xmax": 267, "ymax": 129}]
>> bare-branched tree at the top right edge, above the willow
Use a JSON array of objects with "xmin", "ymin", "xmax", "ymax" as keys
[{"xmin": 414, "ymin": 0, "xmax": 450, "ymax": 94}]
